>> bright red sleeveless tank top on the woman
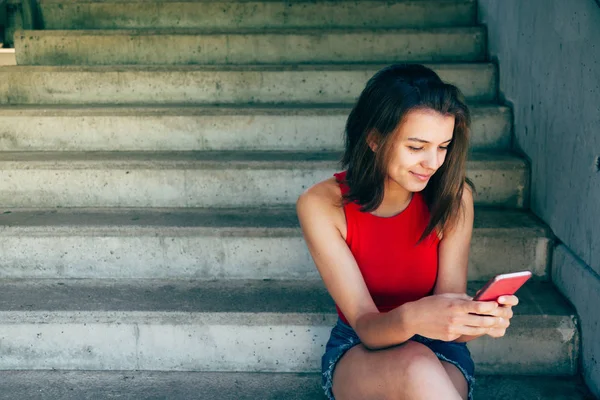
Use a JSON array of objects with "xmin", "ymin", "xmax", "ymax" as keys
[{"xmin": 334, "ymin": 172, "xmax": 439, "ymax": 323}]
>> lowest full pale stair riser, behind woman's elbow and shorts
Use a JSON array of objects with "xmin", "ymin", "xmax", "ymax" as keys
[{"xmin": 0, "ymin": 313, "xmax": 578, "ymax": 375}]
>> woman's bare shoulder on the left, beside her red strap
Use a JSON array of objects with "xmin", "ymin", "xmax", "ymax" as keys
[{"xmin": 296, "ymin": 177, "xmax": 345, "ymax": 231}]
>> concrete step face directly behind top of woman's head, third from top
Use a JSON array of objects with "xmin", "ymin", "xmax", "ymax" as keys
[{"xmin": 0, "ymin": 64, "xmax": 497, "ymax": 105}]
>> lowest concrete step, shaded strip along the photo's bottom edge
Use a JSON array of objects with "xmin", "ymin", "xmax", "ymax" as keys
[{"xmin": 0, "ymin": 371, "xmax": 594, "ymax": 400}]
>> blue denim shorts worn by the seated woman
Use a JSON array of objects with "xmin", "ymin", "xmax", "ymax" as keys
[{"xmin": 321, "ymin": 319, "xmax": 475, "ymax": 400}]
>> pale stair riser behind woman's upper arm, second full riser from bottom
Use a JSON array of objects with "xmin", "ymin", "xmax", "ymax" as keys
[{"xmin": 0, "ymin": 236, "xmax": 550, "ymax": 280}]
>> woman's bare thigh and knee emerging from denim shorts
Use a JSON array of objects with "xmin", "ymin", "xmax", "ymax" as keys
[{"xmin": 333, "ymin": 342, "xmax": 464, "ymax": 400}]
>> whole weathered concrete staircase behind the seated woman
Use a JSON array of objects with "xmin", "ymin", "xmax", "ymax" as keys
[{"xmin": 0, "ymin": 0, "xmax": 591, "ymax": 400}]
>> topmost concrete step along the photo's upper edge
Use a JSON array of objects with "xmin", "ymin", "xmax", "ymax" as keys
[{"xmin": 39, "ymin": 0, "xmax": 477, "ymax": 30}]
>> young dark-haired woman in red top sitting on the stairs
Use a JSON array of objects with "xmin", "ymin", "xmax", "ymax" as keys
[{"xmin": 297, "ymin": 65, "xmax": 518, "ymax": 400}]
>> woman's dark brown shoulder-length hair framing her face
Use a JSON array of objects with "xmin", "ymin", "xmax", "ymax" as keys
[{"xmin": 342, "ymin": 64, "xmax": 474, "ymax": 241}]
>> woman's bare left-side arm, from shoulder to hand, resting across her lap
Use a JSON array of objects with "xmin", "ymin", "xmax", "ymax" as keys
[{"xmin": 297, "ymin": 180, "xmax": 498, "ymax": 349}]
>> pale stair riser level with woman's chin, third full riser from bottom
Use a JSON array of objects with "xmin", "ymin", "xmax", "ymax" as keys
[{"xmin": 0, "ymin": 163, "xmax": 527, "ymax": 208}]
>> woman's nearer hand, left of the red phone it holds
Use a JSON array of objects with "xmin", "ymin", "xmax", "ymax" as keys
[{"xmin": 404, "ymin": 293, "xmax": 504, "ymax": 342}]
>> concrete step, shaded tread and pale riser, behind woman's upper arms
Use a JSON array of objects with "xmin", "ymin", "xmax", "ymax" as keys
[{"xmin": 0, "ymin": 207, "xmax": 552, "ymax": 280}]
